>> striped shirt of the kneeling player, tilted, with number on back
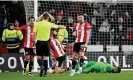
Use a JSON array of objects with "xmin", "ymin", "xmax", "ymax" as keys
[{"xmin": 50, "ymin": 38, "xmax": 65, "ymax": 58}]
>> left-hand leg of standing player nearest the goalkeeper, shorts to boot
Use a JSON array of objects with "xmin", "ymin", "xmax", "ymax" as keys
[{"xmin": 70, "ymin": 43, "xmax": 80, "ymax": 76}]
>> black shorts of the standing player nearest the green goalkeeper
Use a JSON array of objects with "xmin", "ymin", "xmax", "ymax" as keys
[{"xmin": 73, "ymin": 42, "xmax": 87, "ymax": 53}]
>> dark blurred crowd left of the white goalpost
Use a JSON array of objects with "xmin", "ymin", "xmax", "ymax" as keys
[{"xmin": 0, "ymin": 0, "xmax": 26, "ymax": 41}]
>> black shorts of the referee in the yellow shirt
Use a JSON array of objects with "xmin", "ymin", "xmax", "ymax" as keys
[{"xmin": 36, "ymin": 41, "xmax": 50, "ymax": 56}]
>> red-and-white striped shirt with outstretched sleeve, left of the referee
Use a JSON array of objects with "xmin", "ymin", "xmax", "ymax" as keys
[{"xmin": 15, "ymin": 25, "xmax": 33, "ymax": 48}]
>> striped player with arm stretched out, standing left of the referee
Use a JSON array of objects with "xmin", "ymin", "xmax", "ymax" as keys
[{"xmin": 15, "ymin": 17, "xmax": 35, "ymax": 75}]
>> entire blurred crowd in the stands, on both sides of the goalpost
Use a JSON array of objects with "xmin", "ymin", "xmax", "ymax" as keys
[{"xmin": 0, "ymin": 0, "xmax": 133, "ymax": 52}]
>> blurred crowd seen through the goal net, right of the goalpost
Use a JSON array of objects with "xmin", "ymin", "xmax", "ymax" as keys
[{"xmin": 38, "ymin": 1, "xmax": 133, "ymax": 45}]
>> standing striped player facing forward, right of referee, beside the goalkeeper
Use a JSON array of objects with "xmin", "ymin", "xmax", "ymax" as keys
[{"xmin": 70, "ymin": 15, "xmax": 90, "ymax": 76}]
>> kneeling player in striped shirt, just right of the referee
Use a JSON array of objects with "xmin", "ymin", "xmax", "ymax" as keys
[{"xmin": 50, "ymin": 30, "xmax": 68, "ymax": 73}]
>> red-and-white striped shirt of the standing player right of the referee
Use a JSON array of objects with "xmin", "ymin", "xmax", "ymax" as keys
[{"xmin": 74, "ymin": 22, "xmax": 90, "ymax": 42}]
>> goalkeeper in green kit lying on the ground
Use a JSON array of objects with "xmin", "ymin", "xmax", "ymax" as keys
[{"xmin": 76, "ymin": 61, "xmax": 121, "ymax": 74}]
